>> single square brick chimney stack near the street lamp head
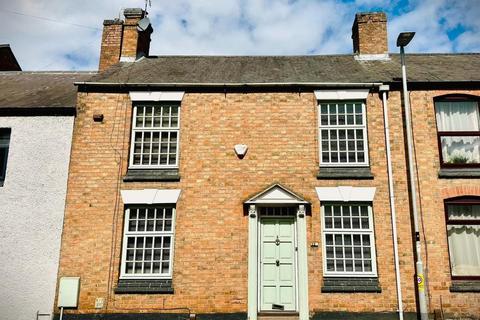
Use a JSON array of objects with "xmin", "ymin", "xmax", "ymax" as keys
[{"xmin": 352, "ymin": 12, "xmax": 388, "ymax": 59}]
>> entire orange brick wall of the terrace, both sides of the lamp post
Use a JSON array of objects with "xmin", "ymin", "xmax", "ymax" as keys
[{"xmin": 54, "ymin": 88, "xmax": 479, "ymax": 314}]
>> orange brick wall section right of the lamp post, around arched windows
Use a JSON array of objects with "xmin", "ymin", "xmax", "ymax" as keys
[{"xmin": 411, "ymin": 90, "xmax": 480, "ymax": 316}]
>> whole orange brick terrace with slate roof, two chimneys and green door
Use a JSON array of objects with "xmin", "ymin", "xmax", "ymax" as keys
[{"xmin": 55, "ymin": 9, "xmax": 480, "ymax": 320}]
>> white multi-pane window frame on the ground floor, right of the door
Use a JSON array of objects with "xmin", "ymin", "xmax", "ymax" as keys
[{"xmin": 320, "ymin": 201, "xmax": 378, "ymax": 277}]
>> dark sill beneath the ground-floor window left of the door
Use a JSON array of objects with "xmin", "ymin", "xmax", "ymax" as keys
[{"xmin": 115, "ymin": 279, "xmax": 173, "ymax": 294}]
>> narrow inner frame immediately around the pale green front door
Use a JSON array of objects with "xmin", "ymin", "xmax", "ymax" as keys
[{"xmin": 257, "ymin": 215, "xmax": 299, "ymax": 313}]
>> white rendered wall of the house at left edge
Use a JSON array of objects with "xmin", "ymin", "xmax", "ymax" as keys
[{"xmin": 0, "ymin": 117, "xmax": 74, "ymax": 320}]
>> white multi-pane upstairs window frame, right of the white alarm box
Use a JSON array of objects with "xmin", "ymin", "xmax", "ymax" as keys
[{"xmin": 317, "ymin": 99, "xmax": 370, "ymax": 167}]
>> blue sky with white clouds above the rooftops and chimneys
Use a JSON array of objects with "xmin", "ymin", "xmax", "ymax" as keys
[{"xmin": 0, "ymin": 0, "xmax": 480, "ymax": 71}]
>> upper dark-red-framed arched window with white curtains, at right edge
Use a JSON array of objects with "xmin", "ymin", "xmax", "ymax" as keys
[{"xmin": 435, "ymin": 95, "xmax": 480, "ymax": 168}]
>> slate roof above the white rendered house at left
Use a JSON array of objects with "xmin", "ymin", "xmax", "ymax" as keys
[{"xmin": 0, "ymin": 72, "xmax": 94, "ymax": 109}]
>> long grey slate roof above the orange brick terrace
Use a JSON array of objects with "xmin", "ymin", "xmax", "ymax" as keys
[{"xmin": 84, "ymin": 53, "xmax": 480, "ymax": 85}]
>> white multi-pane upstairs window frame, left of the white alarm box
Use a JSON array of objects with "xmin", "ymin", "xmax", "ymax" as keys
[{"xmin": 129, "ymin": 101, "xmax": 181, "ymax": 169}]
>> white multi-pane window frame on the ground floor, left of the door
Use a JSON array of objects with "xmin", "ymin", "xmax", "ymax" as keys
[{"xmin": 120, "ymin": 204, "xmax": 176, "ymax": 279}]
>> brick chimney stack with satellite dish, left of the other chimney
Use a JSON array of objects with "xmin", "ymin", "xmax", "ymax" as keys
[{"xmin": 98, "ymin": 8, "xmax": 153, "ymax": 71}]
